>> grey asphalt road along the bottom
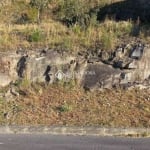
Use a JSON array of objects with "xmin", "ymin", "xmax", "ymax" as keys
[{"xmin": 0, "ymin": 135, "xmax": 150, "ymax": 150}]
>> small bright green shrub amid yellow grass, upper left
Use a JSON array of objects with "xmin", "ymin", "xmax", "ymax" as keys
[{"xmin": 28, "ymin": 29, "xmax": 44, "ymax": 42}]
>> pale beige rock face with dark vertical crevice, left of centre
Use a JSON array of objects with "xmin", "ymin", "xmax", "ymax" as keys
[{"xmin": 25, "ymin": 50, "xmax": 75, "ymax": 83}]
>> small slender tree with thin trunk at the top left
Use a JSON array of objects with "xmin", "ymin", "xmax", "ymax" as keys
[{"xmin": 30, "ymin": 0, "xmax": 51, "ymax": 23}]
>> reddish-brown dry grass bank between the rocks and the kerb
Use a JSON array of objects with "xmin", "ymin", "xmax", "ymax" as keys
[{"xmin": 0, "ymin": 85, "xmax": 150, "ymax": 127}]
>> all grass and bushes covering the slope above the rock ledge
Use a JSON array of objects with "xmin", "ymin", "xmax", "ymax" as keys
[{"xmin": 0, "ymin": 0, "xmax": 150, "ymax": 51}]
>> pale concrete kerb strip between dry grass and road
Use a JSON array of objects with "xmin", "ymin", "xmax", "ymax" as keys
[{"xmin": 0, "ymin": 126, "xmax": 150, "ymax": 137}]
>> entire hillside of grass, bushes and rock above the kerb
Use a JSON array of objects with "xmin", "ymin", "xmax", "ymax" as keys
[{"xmin": 0, "ymin": 0, "xmax": 150, "ymax": 128}]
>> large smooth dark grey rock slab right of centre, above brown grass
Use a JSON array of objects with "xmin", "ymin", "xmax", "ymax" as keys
[{"xmin": 81, "ymin": 63, "xmax": 120, "ymax": 90}]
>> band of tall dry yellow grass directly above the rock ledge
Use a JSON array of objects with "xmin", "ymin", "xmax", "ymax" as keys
[{"xmin": 0, "ymin": 20, "xmax": 132, "ymax": 51}]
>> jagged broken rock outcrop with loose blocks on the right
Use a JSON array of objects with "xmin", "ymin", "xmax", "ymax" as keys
[{"xmin": 77, "ymin": 41, "xmax": 150, "ymax": 89}]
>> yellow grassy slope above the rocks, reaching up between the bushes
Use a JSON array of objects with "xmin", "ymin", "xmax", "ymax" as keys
[{"xmin": 0, "ymin": 0, "xmax": 149, "ymax": 51}]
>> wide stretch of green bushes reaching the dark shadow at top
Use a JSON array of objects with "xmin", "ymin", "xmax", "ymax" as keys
[{"xmin": 54, "ymin": 0, "xmax": 113, "ymax": 27}]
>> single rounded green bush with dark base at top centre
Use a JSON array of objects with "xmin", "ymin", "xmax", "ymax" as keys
[{"xmin": 56, "ymin": 0, "xmax": 89, "ymax": 26}]
